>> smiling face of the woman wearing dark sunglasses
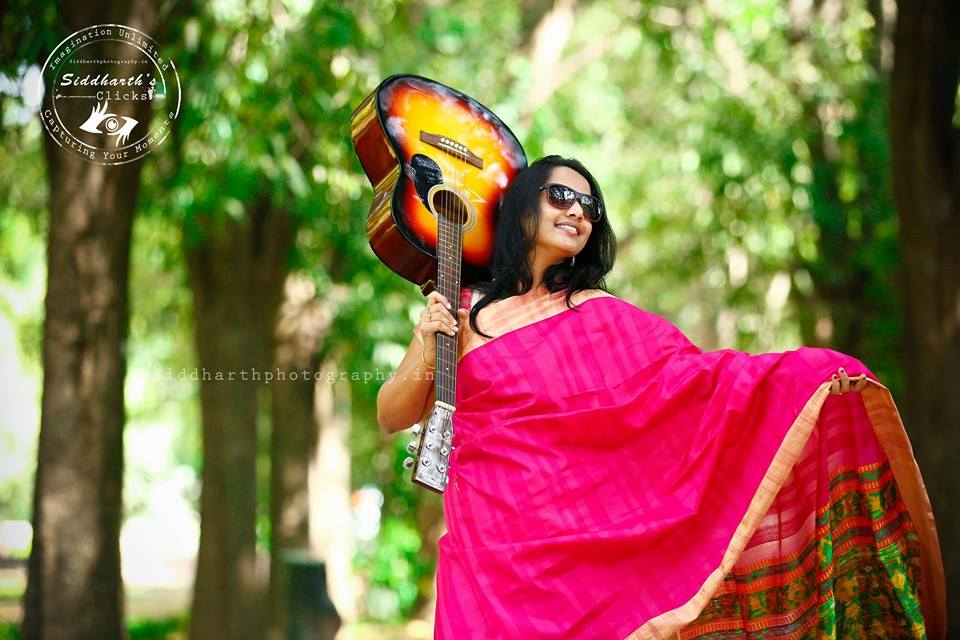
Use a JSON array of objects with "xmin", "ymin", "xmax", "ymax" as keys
[{"xmin": 532, "ymin": 166, "xmax": 593, "ymax": 267}]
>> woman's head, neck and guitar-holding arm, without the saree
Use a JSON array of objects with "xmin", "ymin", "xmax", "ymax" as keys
[{"xmin": 377, "ymin": 156, "xmax": 616, "ymax": 432}]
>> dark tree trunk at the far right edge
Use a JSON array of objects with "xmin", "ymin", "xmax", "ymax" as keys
[{"xmin": 891, "ymin": 0, "xmax": 960, "ymax": 625}]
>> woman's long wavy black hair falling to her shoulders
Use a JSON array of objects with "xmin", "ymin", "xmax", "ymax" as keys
[{"xmin": 470, "ymin": 156, "xmax": 617, "ymax": 338}]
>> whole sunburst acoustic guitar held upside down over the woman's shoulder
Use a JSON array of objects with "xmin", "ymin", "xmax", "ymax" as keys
[{"xmin": 350, "ymin": 75, "xmax": 527, "ymax": 493}]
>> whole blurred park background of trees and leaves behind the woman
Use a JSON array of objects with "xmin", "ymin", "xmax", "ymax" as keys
[{"xmin": 0, "ymin": 0, "xmax": 960, "ymax": 640}]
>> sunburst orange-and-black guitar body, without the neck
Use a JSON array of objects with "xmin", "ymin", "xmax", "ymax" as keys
[{"xmin": 351, "ymin": 75, "xmax": 527, "ymax": 287}]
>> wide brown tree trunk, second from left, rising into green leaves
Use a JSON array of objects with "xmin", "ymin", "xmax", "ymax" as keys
[{"xmin": 186, "ymin": 206, "xmax": 292, "ymax": 640}]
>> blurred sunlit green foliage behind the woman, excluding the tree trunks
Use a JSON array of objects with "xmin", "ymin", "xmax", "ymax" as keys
[{"xmin": 0, "ymin": 0, "xmax": 901, "ymax": 624}]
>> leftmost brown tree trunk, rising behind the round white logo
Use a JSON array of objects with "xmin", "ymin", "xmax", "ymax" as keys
[{"xmin": 21, "ymin": 2, "xmax": 155, "ymax": 640}]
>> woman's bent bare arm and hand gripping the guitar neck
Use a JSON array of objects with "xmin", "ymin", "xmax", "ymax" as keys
[{"xmin": 377, "ymin": 291, "xmax": 467, "ymax": 433}]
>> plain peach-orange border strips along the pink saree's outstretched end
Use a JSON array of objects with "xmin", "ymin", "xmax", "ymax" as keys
[{"xmin": 625, "ymin": 378, "xmax": 947, "ymax": 640}]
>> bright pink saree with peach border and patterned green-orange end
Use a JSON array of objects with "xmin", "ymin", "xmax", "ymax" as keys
[{"xmin": 435, "ymin": 292, "xmax": 945, "ymax": 640}]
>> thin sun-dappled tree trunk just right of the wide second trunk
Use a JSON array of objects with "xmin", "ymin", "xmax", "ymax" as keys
[{"xmin": 268, "ymin": 275, "xmax": 330, "ymax": 640}]
